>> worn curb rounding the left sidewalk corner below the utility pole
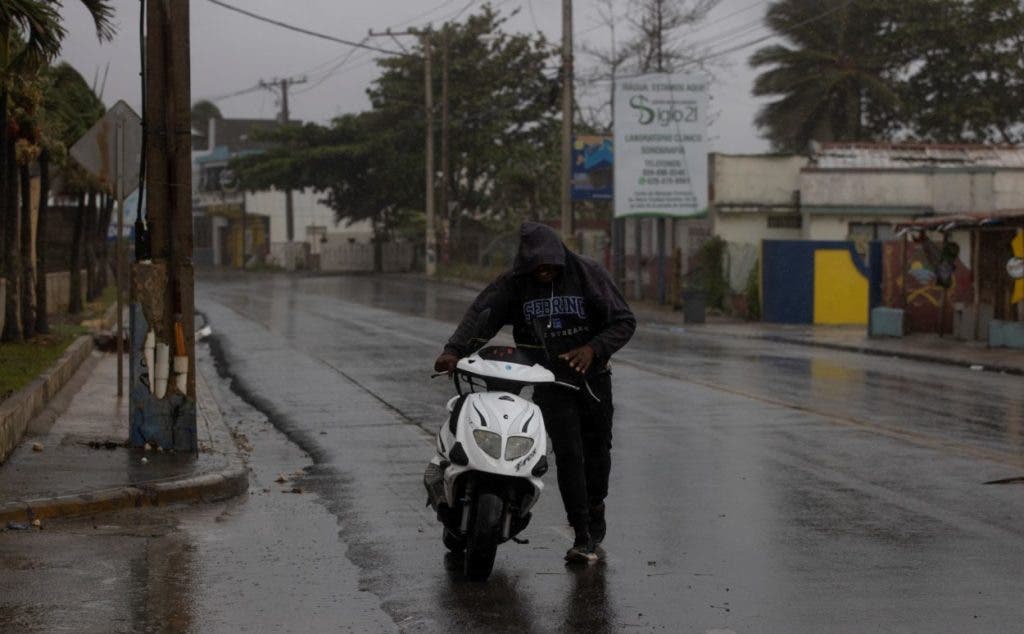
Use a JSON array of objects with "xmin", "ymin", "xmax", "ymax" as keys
[{"xmin": 0, "ymin": 344, "xmax": 249, "ymax": 527}]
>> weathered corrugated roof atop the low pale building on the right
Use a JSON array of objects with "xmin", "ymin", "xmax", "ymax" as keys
[{"xmin": 810, "ymin": 142, "xmax": 1024, "ymax": 169}]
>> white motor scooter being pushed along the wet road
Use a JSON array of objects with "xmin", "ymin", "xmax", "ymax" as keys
[{"xmin": 423, "ymin": 346, "xmax": 575, "ymax": 580}]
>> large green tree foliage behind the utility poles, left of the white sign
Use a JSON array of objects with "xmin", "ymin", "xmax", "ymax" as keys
[{"xmin": 232, "ymin": 5, "xmax": 559, "ymax": 245}]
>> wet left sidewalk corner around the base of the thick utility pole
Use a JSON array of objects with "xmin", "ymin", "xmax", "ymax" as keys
[{"xmin": 0, "ymin": 351, "xmax": 248, "ymax": 531}]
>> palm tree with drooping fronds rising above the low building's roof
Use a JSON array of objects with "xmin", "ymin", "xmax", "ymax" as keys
[{"xmin": 750, "ymin": 0, "xmax": 913, "ymax": 152}]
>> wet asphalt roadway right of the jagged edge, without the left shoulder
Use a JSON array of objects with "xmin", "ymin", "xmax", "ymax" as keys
[{"xmin": 193, "ymin": 277, "xmax": 1024, "ymax": 632}]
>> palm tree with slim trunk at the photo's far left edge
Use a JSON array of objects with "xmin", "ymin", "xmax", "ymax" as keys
[{"xmin": 0, "ymin": 0, "xmax": 114, "ymax": 341}]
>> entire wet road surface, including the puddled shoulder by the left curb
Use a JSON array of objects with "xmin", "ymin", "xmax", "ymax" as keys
[{"xmin": 0, "ymin": 274, "xmax": 1024, "ymax": 633}]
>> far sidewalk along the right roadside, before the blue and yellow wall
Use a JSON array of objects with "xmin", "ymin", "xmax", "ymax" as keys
[{"xmin": 633, "ymin": 305, "xmax": 1024, "ymax": 375}]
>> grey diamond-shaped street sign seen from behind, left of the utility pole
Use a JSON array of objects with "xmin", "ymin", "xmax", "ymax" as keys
[{"xmin": 71, "ymin": 100, "xmax": 142, "ymax": 197}]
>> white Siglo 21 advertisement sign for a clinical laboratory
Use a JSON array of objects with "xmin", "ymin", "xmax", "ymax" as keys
[{"xmin": 614, "ymin": 73, "xmax": 711, "ymax": 217}]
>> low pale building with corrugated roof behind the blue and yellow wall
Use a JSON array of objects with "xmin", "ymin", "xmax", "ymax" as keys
[{"xmin": 709, "ymin": 142, "xmax": 1024, "ymax": 292}]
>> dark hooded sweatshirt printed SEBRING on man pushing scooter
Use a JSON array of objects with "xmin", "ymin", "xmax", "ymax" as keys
[{"xmin": 444, "ymin": 222, "xmax": 636, "ymax": 380}]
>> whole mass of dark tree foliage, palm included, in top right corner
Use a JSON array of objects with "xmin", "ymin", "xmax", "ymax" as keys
[{"xmin": 751, "ymin": 0, "xmax": 1024, "ymax": 152}]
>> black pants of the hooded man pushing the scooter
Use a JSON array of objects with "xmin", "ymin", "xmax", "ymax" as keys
[{"xmin": 534, "ymin": 372, "xmax": 614, "ymax": 530}]
